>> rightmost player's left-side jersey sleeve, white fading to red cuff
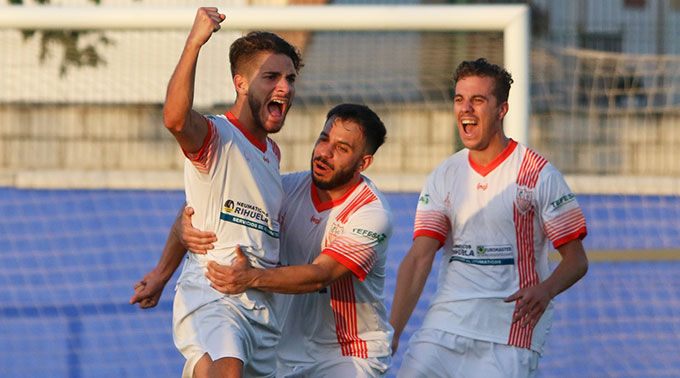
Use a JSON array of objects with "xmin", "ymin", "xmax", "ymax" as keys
[{"xmin": 413, "ymin": 170, "xmax": 451, "ymax": 247}]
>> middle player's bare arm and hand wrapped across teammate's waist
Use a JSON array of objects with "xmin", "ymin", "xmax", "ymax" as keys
[{"xmin": 206, "ymin": 246, "xmax": 350, "ymax": 294}]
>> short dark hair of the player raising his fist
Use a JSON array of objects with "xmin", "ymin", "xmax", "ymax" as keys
[{"xmin": 229, "ymin": 31, "xmax": 304, "ymax": 77}]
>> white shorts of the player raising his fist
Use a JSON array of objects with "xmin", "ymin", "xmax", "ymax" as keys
[{"xmin": 173, "ymin": 284, "xmax": 280, "ymax": 378}]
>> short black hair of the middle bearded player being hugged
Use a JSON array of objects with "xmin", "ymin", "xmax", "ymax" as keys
[{"xmin": 326, "ymin": 104, "xmax": 387, "ymax": 155}]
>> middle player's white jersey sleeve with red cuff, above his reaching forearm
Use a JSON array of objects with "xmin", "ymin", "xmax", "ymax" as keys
[{"xmin": 321, "ymin": 204, "xmax": 392, "ymax": 281}]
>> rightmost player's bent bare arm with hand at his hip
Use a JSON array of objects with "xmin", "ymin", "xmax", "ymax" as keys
[{"xmin": 505, "ymin": 239, "xmax": 588, "ymax": 327}]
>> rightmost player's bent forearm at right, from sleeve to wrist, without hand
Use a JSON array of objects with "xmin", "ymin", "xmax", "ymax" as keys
[{"xmin": 543, "ymin": 240, "xmax": 588, "ymax": 298}]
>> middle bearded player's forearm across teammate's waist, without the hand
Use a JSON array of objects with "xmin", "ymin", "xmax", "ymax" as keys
[{"xmin": 251, "ymin": 264, "xmax": 333, "ymax": 294}]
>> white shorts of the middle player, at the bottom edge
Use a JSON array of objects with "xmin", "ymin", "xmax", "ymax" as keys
[{"xmin": 276, "ymin": 356, "xmax": 391, "ymax": 378}]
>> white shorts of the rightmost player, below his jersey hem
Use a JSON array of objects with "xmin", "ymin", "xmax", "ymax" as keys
[{"xmin": 398, "ymin": 329, "xmax": 540, "ymax": 378}]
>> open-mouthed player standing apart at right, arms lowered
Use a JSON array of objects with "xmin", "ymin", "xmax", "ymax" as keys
[{"xmin": 390, "ymin": 59, "xmax": 588, "ymax": 378}]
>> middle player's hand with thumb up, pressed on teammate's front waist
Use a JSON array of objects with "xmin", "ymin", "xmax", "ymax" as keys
[{"xmin": 205, "ymin": 245, "xmax": 255, "ymax": 294}]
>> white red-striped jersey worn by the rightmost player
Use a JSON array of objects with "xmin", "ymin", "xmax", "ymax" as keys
[{"xmin": 414, "ymin": 140, "xmax": 586, "ymax": 353}]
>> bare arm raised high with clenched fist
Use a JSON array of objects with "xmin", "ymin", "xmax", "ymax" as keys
[{"xmin": 163, "ymin": 7, "xmax": 225, "ymax": 153}]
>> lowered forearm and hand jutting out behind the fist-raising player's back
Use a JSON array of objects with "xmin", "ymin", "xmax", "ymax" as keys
[{"xmin": 130, "ymin": 206, "xmax": 186, "ymax": 308}]
